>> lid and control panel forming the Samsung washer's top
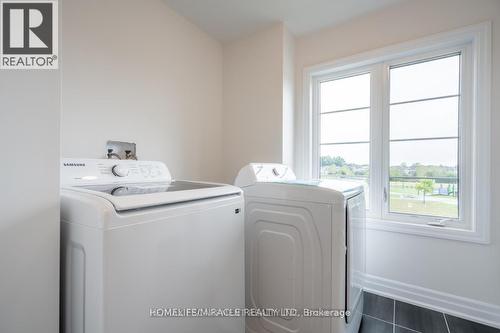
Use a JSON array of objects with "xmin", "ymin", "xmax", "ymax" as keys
[{"xmin": 61, "ymin": 159, "xmax": 241, "ymax": 211}]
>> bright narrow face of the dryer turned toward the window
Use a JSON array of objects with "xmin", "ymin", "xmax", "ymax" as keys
[{"xmin": 345, "ymin": 193, "xmax": 365, "ymax": 323}]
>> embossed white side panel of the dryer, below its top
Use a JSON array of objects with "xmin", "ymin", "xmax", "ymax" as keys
[{"xmin": 245, "ymin": 197, "xmax": 332, "ymax": 333}]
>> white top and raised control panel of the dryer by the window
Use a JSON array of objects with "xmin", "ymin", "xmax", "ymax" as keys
[{"xmin": 235, "ymin": 163, "xmax": 363, "ymax": 203}]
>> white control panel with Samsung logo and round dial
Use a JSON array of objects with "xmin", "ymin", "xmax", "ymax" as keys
[{"xmin": 61, "ymin": 158, "xmax": 172, "ymax": 187}]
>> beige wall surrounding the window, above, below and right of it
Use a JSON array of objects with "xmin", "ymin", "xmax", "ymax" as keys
[{"xmin": 295, "ymin": 0, "xmax": 500, "ymax": 305}]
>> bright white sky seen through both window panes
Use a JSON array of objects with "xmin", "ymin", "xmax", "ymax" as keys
[{"xmin": 320, "ymin": 55, "xmax": 460, "ymax": 166}]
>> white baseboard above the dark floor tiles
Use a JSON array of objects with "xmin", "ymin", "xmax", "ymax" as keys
[{"xmin": 365, "ymin": 274, "xmax": 500, "ymax": 328}]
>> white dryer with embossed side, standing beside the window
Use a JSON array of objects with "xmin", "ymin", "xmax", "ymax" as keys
[{"xmin": 235, "ymin": 164, "xmax": 365, "ymax": 333}]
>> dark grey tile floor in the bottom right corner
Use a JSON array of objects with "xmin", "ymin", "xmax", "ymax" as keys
[{"xmin": 359, "ymin": 292, "xmax": 500, "ymax": 333}]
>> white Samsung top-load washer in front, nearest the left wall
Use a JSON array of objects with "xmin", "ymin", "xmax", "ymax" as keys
[{"xmin": 61, "ymin": 159, "xmax": 244, "ymax": 333}]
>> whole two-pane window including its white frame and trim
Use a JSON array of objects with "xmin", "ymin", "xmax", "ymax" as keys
[{"xmin": 302, "ymin": 24, "xmax": 491, "ymax": 242}]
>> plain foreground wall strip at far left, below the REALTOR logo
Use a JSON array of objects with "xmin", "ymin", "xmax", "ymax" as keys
[{"xmin": 0, "ymin": 60, "xmax": 60, "ymax": 333}]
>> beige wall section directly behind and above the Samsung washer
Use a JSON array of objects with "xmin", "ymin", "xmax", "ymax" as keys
[{"xmin": 61, "ymin": 0, "xmax": 222, "ymax": 180}]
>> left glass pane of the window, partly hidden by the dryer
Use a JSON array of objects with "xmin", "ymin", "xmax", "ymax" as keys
[{"xmin": 320, "ymin": 73, "xmax": 370, "ymax": 205}]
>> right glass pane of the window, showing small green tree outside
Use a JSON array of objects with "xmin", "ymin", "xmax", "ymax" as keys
[{"xmin": 388, "ymin": 53, "xmax": 461, "ymax": 220}]
